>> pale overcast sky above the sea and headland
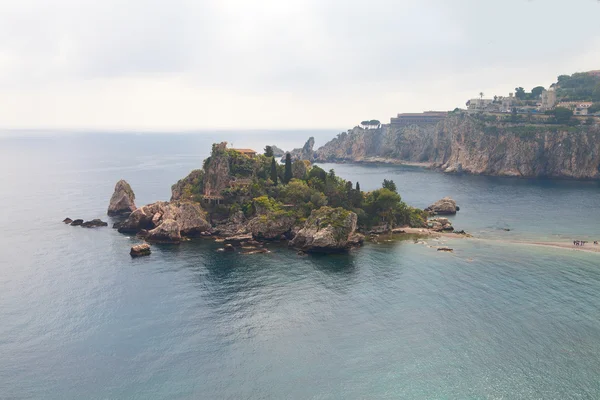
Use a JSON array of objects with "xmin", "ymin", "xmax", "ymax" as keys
[{"xmin": 0, "ymin": 0, "xmax": 600, "ymax": 130}]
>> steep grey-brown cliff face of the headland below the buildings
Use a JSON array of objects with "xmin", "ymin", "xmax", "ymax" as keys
[{"xmin": 316, "ymin": 115, "xmax": 600, "ymax": 179}]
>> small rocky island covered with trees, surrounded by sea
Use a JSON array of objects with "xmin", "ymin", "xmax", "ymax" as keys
[{"xmin": 109, "ymin": 141, "xmax": 455, "ymax": 256}]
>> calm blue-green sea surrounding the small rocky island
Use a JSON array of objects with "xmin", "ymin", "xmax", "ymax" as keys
[{"xmin": 0, "ymin": 131, "xmax": 600, "ymax": 399}]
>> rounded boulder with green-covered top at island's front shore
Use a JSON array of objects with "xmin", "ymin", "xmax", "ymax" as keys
[{"xmin": 289, "ymin": 207, "xmax": 361, "ymax": 253}]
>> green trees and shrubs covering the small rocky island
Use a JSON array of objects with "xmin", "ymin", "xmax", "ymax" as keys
[{"xmin": 174, "ymin": 143, "xmax": 427, "ymax": 231}]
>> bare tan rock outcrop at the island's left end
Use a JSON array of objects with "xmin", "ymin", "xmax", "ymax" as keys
[{"xmin": 118, "ymin": 201, "xmax": 211, "ymax": 240}]
